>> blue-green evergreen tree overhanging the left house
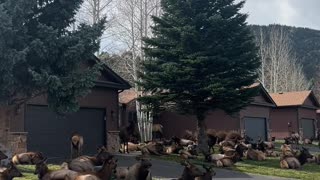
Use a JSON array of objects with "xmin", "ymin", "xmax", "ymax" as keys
[{"xmin": 0, "ymin": 0, "xmax": 105, "ymax": 113}]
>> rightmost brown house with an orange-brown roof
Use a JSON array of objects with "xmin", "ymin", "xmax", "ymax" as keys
[{"xmin": 270, "ymin": 91, "xmax": 319, "ymax": 139}]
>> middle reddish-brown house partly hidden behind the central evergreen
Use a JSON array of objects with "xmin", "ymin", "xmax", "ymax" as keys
[{"xmin": 123, "ymin": 83, "xmax": 276, "ymax": 139}]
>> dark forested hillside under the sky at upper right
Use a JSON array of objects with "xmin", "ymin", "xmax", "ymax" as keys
[{"xmin": 250, "ymin": 25, "xmax": 320, "ymax": 79}]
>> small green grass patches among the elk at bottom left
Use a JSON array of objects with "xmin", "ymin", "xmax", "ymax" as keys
[{"xmin": 14, "ymin": 164, "xmax": 61, "ymax": 180}]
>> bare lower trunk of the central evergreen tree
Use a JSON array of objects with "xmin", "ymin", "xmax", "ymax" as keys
[{"xmin": 197, "ymin": 114, "xmax": 209, "ymax": 153}]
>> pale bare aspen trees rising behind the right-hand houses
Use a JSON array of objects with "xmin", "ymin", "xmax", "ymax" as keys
[{"xmin": 256, "ymin": 26, "xmax": 311, "ymax": 93}]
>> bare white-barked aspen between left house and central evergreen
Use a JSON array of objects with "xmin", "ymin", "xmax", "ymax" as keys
[{"xmin": 109, "ymin": 0, "xmax": 161, "ymax": 140}]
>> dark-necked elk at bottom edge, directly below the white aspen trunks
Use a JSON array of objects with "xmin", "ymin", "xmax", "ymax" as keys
[{"xmin": 126, "ymin": 156, "xmax": 152, "ymax": 180}]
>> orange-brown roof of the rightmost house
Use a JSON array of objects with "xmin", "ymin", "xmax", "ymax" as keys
[{"xmin": 270, "ymin": 91, "xmax": 319, "ymax": 107}]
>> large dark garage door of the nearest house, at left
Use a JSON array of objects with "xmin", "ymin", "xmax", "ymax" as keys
[{"xmin": 25, "ymin": 105, "xmax": 105, "ymax": 162}]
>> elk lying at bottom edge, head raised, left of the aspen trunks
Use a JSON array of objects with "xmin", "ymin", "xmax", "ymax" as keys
[{"xmin": 65, "ymin": 158, "xmax": 118, "ymax": 180}]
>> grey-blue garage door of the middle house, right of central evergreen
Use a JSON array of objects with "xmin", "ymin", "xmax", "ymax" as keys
[{"xmin": 244, "ymin": 118, "xmax": 267, "ymax": 140}]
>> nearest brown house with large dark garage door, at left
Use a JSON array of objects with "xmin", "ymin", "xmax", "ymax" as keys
[{"xmin": 0, "ymin": 60, "xmax": 130, "ymax": 160}]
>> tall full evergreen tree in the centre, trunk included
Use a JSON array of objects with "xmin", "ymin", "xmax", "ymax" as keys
[{"xmin": 140, "ymin": 0, "xmax": 260, "ymax": 151}]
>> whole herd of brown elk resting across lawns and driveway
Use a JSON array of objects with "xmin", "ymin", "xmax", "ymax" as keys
[{"xmin": 0, "ymin": 123, "xmax": 320, "ymax": 180}]
